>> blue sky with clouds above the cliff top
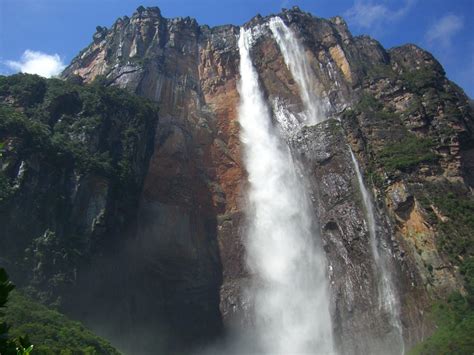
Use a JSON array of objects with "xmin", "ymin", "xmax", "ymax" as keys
[{"xmin": 0, "ymin": 0, "xmax": 474, "ymax": 98}]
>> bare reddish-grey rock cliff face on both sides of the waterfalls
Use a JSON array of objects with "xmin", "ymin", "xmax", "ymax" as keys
[{"xmin": 63, "ymin": 4, "xmax": 474, "ymax": 353}]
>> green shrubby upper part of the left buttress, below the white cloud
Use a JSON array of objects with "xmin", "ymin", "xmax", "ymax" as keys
[{"xmin": 0, "ymin": 74, "xmax": 157, "ymax": 185}]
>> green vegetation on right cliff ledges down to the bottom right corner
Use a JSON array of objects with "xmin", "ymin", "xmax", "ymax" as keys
[{"xmin": 344, "ymin": 82, "xmax": 474, "ymax": 354}]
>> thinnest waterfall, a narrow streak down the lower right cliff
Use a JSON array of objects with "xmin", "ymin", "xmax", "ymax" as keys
[{"xmin": 350, "ymin": 149, "xmax": 405, "ymax": 354}]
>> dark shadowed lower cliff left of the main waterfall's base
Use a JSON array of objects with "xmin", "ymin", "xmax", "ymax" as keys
[{"xmin": 64, "ymin": 191, "xmax": 222, "ymax": 355}]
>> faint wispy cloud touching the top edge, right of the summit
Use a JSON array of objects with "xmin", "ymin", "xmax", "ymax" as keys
[{"xmin": 344, "ymin": 0, "xmax": 416, "ymax": 28}]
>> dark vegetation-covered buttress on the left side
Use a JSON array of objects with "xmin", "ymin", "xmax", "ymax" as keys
[{"xmin": 0, "ymin": 74, "xmax": 158, "ymax": 303}]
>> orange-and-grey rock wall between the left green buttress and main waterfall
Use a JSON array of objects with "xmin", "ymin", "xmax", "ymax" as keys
[{"xmin": 64, "ymin": 8, "xmax": 243, "ymax": 354}]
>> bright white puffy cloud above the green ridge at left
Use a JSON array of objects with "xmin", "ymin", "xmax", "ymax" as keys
[{"xmin": 5, "ymin": 50, "xmax": 65, "ymax": 78}]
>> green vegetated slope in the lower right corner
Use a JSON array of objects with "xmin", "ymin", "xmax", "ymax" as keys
[{"xmin": 411, "ymin": 183, "xmax": 474, "ymax": 354}]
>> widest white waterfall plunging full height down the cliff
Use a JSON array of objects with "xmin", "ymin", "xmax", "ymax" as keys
[{"xmin": 239, "ymin": 28, "xmax": 334, "ymax": 354}]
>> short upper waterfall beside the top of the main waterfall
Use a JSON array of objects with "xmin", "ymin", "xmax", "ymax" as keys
[{"xmin": 268, "ymin": 17, "xmax": 325, "ymax": 125}]
